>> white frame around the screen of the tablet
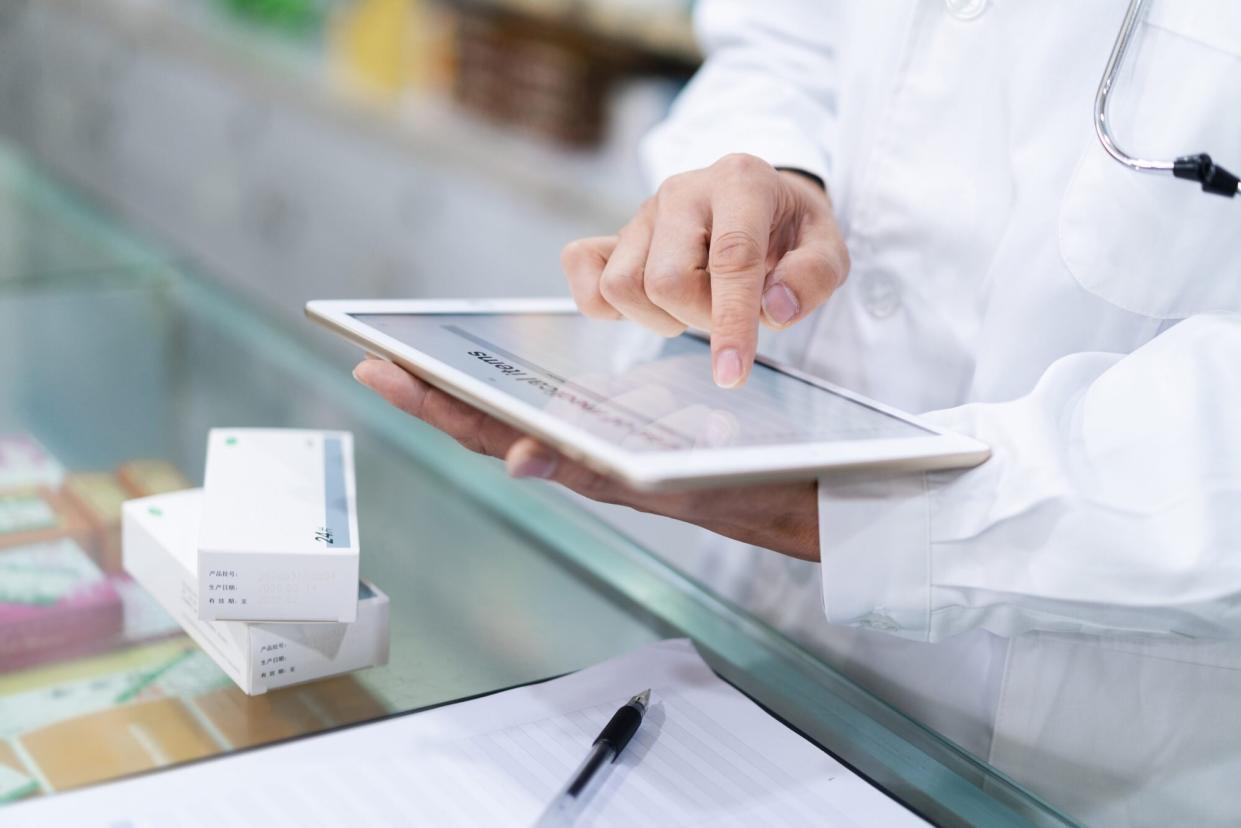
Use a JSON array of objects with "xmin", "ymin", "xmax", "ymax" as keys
[{"xmin": 305, "ymin": 299, "xmax": 990, "ymax": 492}]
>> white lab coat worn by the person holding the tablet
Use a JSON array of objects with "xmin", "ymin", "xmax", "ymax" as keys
[{"xmin": 644, "ymin": 0, "xmax": 1241, "ymax": 826}]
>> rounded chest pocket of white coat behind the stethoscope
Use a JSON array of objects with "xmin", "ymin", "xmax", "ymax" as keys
[{"xmin": 1059, "ymin": 1, "xmax": 1241, "ymax": 319}]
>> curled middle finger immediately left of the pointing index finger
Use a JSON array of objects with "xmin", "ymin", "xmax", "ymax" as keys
[{"xmin": 643, "ymin": 176, "xmax": 711, "ymax": 330}]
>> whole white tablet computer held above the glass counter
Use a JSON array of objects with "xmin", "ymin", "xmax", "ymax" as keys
[{"xmin": 307, "ymin": 299, "xmax": 988, "ymax": 490}]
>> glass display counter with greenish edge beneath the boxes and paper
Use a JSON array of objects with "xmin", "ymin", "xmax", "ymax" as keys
[{"xmin": 0, "ymin": 150, "xmax": 1067, "ymax": 826}]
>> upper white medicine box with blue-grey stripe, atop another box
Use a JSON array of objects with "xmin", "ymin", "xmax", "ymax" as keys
[{"xmin": 197, "ymin": 428, "xmax": 359, "ymax": 621}]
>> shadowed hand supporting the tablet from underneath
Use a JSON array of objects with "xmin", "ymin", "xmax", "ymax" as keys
[{"xmin": 354, "ymin": 359, "xmax": 819, "ymax": 560}]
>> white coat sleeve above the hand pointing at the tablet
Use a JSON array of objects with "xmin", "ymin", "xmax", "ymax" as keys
[{"xmin": 642, "ymin": 0, "xmax": 840, "ymax": 186}]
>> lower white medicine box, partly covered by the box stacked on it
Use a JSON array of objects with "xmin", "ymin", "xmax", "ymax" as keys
[{"xmin": 122, "ymin": 489, "xmax": 388, "ymax": 695}]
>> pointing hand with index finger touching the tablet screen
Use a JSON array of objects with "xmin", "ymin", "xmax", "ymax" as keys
[{"xmin": 561, "ymin": 155, "xmax": 849, "ymax": 387}]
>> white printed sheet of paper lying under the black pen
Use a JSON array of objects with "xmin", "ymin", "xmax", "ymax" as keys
[{"xmin": 2, "ymin": 641, "xmax": 925, "ymax": 828}]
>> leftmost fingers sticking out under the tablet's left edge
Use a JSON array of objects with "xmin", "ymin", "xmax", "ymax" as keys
[{"xmin": 354, "ymin": 360, "xmax": 521, "ymax": 457}]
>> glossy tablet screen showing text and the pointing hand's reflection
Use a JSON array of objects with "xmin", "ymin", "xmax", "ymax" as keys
[{"xmin": 351, "ymin": 313, "xmax": 932, "ymax": 452}]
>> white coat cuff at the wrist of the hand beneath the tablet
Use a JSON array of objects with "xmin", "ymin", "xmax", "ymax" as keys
[{"xmin": 819, "ymin": 473, "xmax": 931, "ymax": 641}]
